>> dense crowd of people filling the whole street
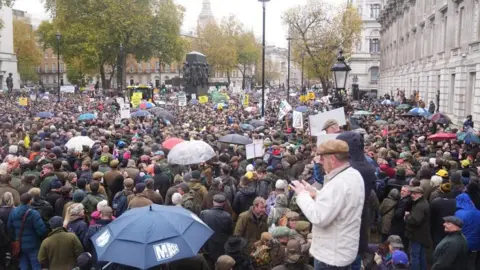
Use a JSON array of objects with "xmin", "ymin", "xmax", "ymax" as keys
[{"xmin": 0, "ymin": 87, "xmax": 480, "ymax": 270}]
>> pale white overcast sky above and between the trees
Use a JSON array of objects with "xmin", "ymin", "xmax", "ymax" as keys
[{"xmin": 14, "ymin": 0, "xmax": 344, "ymax": 47}]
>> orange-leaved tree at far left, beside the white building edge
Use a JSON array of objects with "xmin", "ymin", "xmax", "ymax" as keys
[{"xmin": 13, "ymin": 20, "xmax": 42, "ymax": 83}]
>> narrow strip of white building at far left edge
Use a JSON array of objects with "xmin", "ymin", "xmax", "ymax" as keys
[{"xmin": 0, "ymin": 5, "xmax": 20, "ymax": 90}]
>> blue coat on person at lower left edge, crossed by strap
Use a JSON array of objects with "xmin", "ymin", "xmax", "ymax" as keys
[{"xmin": 8, "ymin": 205, "xmax": 47, "ymax": 251}]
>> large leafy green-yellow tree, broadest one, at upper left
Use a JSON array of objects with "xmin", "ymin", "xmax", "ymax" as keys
[{"xmin": 38, "ymin": 0, "xmax": 184, "ymax": 89}]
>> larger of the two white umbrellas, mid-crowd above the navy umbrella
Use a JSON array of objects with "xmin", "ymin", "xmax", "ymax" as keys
[{"xmin": 168, "ymin": 141, "xmax": 216, "ymax": 165}]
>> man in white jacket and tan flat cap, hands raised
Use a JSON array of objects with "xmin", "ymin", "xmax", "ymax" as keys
[{"xmin": 292, "ymin": 140, "xmax": 365, "ymax": 267}]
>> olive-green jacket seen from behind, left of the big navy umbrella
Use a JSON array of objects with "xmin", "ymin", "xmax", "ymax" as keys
[{"xmin": 38, "ymin": 227, "xmax": 83, "ymax": 270}]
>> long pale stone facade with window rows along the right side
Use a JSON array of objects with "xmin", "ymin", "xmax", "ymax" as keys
[{"xmin": 379, "ymin": 0, "xmax": 480, "ymax": 123}]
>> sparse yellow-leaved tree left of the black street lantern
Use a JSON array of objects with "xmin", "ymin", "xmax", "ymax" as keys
[{"xmin": 282, "ymin": 0, "xmax": 362, "ymax": 94}]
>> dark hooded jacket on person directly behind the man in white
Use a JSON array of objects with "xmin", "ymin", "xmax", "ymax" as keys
[{"xmin": 337, "ymin": 131, "xmax": 376, "ymax": 254}]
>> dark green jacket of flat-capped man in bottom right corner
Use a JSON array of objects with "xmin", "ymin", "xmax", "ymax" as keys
[{"xmin": 432, "ymin": 231, "xmax": 468, "ymax": 270}]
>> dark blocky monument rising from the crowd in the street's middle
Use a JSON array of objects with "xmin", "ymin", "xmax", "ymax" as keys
[{"xmin": 183, "ymin": 52, "xmax": 210, "ymax": 97}]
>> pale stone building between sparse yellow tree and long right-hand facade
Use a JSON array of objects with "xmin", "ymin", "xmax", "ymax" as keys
[{"xmin": 347, "ymin": 0, "xmax": 382, "ymax": 94}]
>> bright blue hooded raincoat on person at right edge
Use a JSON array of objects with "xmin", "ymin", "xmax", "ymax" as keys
[{"xmin": 455, "ymin": 193, "xmax": 480, "ymax": 251}]
